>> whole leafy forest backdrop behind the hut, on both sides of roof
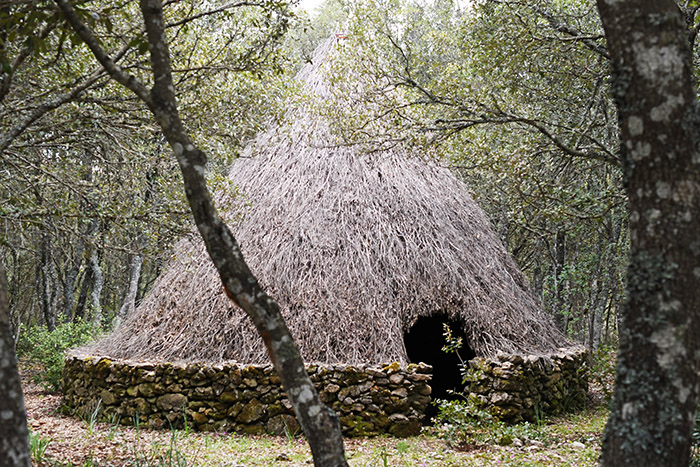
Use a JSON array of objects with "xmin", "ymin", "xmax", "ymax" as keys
[{"xmin": 0, "ymin": 0, "xmax": 628, "ymax": 360}]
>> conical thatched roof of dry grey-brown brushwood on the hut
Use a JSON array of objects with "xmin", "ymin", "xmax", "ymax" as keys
[{"xmin": 93, "ymin": 36, "xmax": 565, "ymax": 363}]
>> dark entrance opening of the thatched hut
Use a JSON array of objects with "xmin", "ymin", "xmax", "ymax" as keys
[{"xmin": 403, "ymin": 315, "xmax": 476, "ymax": 422}]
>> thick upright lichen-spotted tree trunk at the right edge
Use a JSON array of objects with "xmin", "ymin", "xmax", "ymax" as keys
[{"xmin": 598, "ymin": 0, "xmax": 700, "ymax": 467}]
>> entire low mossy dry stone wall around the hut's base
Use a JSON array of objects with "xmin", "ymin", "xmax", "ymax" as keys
[{"xmin": 64, "ymin": 352, "xmax": 586, "ymax": 436}]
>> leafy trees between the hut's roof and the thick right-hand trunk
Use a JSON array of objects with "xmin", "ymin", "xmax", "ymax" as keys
[{"xmin": 329, "ymin": 0, "xmax": 628, "ymax": 346}]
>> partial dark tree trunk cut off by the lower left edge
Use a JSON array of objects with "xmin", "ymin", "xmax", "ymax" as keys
[{"xmin": 0, "ymin": 264, "xmax": 30, "ymax": 467}]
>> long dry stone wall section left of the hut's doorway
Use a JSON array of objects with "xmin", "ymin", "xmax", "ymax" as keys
[{"xmin": 63, "ymin": 355, "xmax": 432, "ymax": 437}]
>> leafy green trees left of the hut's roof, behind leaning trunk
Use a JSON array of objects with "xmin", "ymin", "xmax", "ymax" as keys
[{"xmin": 0, "ymin": 0, "xmax": 294, "ymax": 344}]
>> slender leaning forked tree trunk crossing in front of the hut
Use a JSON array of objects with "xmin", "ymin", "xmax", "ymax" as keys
[{"xmin": 55, "ymin": 0, "xmax": 347, "ymax": 467}]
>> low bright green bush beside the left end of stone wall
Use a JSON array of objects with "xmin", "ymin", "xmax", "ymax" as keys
[{"xmin": 17, "ymin": 320, "xmax": 97, "ymax": 391}]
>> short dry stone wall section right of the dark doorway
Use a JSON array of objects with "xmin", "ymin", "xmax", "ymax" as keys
[{"xmin": 466, "ymin": 348, "xmax": 588, "ymax": 423}]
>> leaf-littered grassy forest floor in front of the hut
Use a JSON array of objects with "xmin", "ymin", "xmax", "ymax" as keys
[{"xmin": 23, "ymin": 374, "xmax": 607, "ymax": 467}]
